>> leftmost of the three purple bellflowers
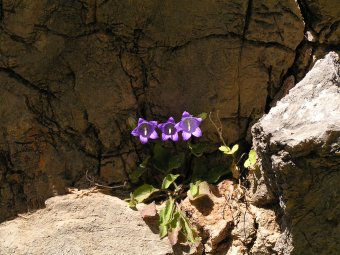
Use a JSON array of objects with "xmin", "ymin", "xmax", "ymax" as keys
[{"xmin": 131, "ymin": 118, "xmax": 158, "ymax": 144}]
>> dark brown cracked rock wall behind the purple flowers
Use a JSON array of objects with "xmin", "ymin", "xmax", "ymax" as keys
[{"xmin": 0, "ymin": 0, "xmax": 340, "ymax": 224}]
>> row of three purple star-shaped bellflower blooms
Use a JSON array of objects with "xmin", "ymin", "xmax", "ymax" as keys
[{"xmin": 131, "ymin": 112, "xmax": 202, "ymax": 144}]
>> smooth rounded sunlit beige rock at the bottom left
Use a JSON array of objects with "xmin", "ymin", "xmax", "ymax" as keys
[{"xmin": 0, "ymin": 191, "xmax": 173, "ymax": 255}]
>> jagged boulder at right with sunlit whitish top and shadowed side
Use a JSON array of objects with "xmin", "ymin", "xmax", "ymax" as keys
[{"xmin": 251, "ymin": 52, "xmax": 340, "ymax": 254}]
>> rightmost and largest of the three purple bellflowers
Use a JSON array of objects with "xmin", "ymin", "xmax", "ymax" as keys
[{"xmin": 175, "ymin": 111, "xmax": 202, "ymax": 141}]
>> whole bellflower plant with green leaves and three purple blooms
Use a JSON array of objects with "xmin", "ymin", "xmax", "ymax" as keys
[{"xmin": 128, "ymin": 112, "xmax": 254, "ymax": 245}]
